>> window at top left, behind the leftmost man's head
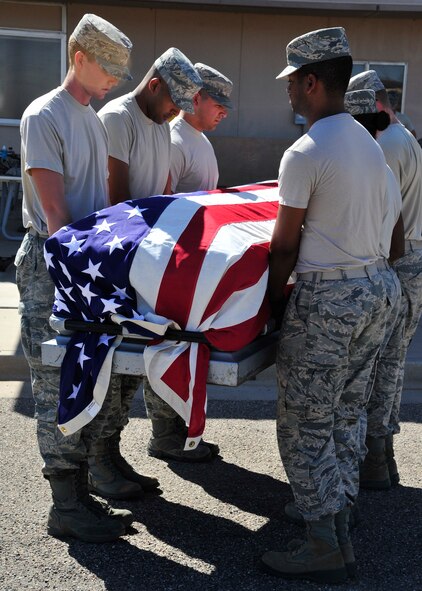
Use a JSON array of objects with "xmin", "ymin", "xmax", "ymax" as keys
[{"xmin": 0, "ymin": 29, "xmax": 66, "ymax": 125}]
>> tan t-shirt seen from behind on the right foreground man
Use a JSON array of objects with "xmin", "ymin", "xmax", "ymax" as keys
[{"xmin": 279, "ymin": 113, "xmax": 387, "ymax": 273}]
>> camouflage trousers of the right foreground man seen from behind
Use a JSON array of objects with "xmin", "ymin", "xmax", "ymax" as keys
[{"xmin": 276, "ymin": 273, "xmax": 387, "ymax": 520}]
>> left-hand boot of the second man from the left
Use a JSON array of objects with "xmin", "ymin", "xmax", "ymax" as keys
[{"xmin": 88, "ymin": 439, "xmax": 144, "ymax": 500}]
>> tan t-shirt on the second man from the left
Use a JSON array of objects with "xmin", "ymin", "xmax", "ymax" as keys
[{"xmin": 98, "ymin": 93, "xmax": 170, "ymax": 199}]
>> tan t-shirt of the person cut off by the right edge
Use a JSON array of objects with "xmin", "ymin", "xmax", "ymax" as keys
[{"xmin": 378, "ymin": 123, "xmax": 422, "ymax": 240}]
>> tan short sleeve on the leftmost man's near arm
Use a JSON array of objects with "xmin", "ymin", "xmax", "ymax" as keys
[{"xmin": 21, "ymin": 113, "xmax": 64, "ymax": 174}]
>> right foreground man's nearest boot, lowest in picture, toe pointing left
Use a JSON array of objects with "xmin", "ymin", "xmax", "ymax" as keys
[{"xmin": 261, "ymin": 515, "xmax": 347, "ymax": 584}]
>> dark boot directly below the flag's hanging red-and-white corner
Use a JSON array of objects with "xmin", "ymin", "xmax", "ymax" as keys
[{"xmin": 147, "ymin": 419, "xmax": 213, "ymax": 462}]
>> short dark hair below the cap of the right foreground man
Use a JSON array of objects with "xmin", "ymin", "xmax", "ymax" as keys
[{"xmin": 298, "ymin": 55, "xmax": 353, "ymax": 96}]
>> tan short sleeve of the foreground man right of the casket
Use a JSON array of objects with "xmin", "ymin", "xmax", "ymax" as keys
[{"xmin": 278, "ymin": 150, "xmax": 316, "ymax": 209}]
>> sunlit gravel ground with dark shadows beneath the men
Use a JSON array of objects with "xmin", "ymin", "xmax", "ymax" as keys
[{"xmin": 0, "ymin": 399, "xmax": 422, "ymax": 591}]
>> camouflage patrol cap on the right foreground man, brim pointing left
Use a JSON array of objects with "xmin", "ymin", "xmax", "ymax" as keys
[{"xmin": 276, "ymin": 27, "xmax": 350, "ymax": 78}]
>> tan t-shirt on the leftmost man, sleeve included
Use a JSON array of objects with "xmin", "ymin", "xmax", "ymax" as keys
[{"xmin": 20, "ymin": 86, "xmax": 108, "ymax": 236}]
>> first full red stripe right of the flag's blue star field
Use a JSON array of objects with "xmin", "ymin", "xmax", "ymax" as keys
[{"xmin": 155, "ymin": 201, "xmax": 278, "ymax": 328}]
